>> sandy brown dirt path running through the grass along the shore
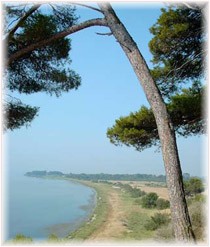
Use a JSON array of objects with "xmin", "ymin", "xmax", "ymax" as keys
[{"xmin": 88, "ymin": 188, "xmax": 125, "ymax": 242}]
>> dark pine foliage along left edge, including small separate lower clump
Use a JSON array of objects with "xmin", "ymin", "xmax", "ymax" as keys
[{"xmin": 4, "ymin": 4, "xmax": 81, "ymax": 130}]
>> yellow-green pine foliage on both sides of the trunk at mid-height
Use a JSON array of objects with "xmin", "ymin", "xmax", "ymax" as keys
[{"xmin": 107, "ymin": 83, "xmax": 203, "ymax": 151}]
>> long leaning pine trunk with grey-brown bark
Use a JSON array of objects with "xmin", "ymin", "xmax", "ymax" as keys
[{"xmin": 98, "ymin": 3, "xmax": 195, "ymax": 242}]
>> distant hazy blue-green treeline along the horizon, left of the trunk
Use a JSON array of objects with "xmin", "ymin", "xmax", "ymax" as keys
[{"xmin": 25, "ymin": 171, "xmax": 174, "ymax": 182}]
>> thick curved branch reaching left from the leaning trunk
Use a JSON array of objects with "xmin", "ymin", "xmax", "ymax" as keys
[{"xmin": 5, "ymin": 18, "xmax": 107, "ymax": 66}]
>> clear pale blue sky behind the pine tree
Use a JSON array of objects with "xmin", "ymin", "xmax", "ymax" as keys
[{"xmin": 3, "ymin": 3, "xmax": 207, "ymax": 176}]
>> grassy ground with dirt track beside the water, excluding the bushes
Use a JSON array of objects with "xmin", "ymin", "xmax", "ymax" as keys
[{"xmin": 67, "ymin": 179, "xmax": 205, "ymax": 243}]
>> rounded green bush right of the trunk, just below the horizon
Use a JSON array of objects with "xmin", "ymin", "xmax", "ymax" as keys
[{"xmin": 184, "ymin": 178, "xmax": 204, "ymax": 196}]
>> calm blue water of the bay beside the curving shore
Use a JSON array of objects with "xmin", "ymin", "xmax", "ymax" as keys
[{"xmin": 5, "ymin": 176, "xmax": 95, "ymax": 240}]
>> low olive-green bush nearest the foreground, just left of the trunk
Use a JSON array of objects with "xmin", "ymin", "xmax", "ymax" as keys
[{"xmin": 144, "ymin": 213, "xmax": 170, "ymax": 231}]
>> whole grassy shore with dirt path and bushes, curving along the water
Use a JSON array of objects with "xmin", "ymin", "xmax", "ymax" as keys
[{"xmin": 13, "ymin": 176, "xmax": 206, "ymax": 244}]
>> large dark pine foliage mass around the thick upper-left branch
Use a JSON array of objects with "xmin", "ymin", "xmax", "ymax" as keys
[{"xmin": 7, "ymin": 8, "xmax": 80, "ymax": 96}]
